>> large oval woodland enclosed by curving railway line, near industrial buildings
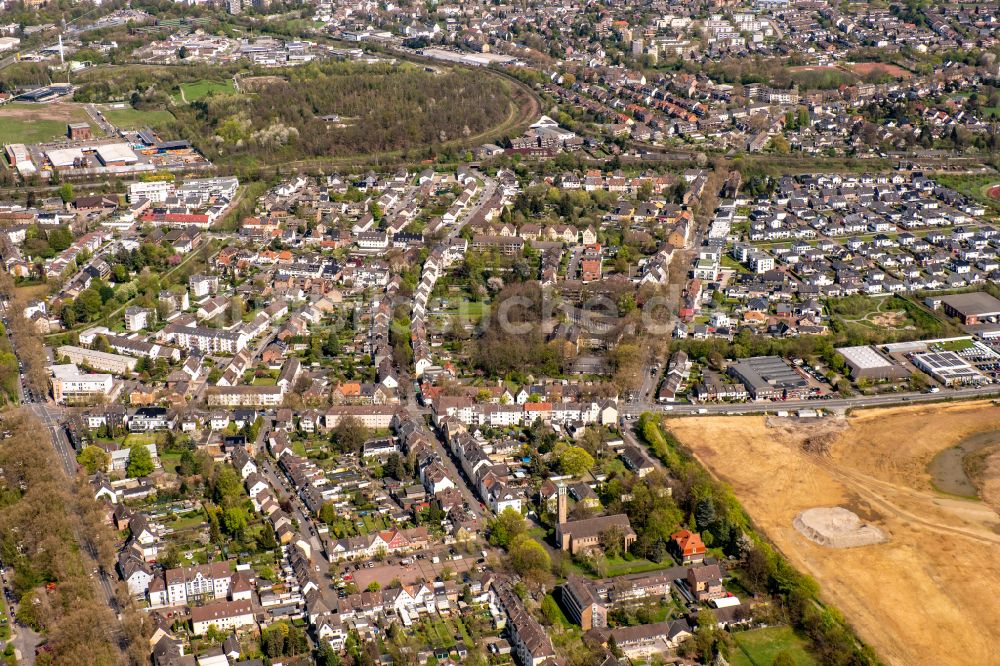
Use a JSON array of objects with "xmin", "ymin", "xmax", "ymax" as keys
[{"xmin": 76, "ymin": 62, "xmax": 511, "ymax": 163}]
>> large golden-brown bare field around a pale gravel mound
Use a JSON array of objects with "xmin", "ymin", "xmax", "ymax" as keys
[{"xmin": 667, "ymin": 402, "xmax": 1000, "ymax": 666}]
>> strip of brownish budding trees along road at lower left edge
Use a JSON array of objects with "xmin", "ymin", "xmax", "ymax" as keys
[{"xmin": 0, "ymin": 412, "xmax": 146, "ymax": 666}]
